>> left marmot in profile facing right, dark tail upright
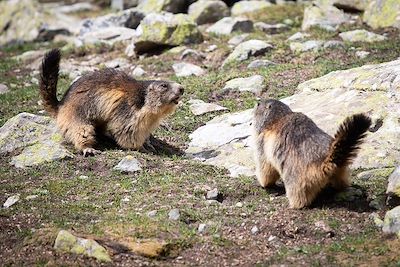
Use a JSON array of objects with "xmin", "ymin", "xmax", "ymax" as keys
[{"xmin": 40, "ymin": 49, "xmax": 184, "ymax": 156}]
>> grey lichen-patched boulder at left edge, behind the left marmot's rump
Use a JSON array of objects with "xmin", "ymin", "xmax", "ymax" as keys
[{"xmin": 0, "ymin": 113, "xmax": 73, "ymax": 168}]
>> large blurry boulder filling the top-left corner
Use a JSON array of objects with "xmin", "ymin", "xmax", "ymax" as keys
[{"xmin": 0, "ymin": 0, "xmax": 72, "ymax": 45}]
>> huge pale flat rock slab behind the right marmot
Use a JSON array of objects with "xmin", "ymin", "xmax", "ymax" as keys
[{"xmin": 186, "ymin": 60, "xmax": 400, "ymax": 176}]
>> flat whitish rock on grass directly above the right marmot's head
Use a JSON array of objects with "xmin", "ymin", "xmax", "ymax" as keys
[{"xmin": 224, "ymin": 75, "xmax": 265, "ymax": 94}]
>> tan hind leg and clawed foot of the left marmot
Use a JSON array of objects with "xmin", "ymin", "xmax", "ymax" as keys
[{"xmin": 65, "ymin": 120, "xmax": 100, "ymax": 157}]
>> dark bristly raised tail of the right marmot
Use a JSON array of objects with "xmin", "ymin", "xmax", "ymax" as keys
[{"xmin": 325, "ymin": 114, "xmax": 371, "ymax": 167}]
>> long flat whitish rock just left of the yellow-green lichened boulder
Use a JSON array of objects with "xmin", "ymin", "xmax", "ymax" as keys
[{"xmin": 75, "ymin": 26, "xmax": 136, "ymax": 47}]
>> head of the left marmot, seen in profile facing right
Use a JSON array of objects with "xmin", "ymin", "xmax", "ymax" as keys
[{"xmin": 145, "ymin": 81, "xmax": 184, "ymax": 115}]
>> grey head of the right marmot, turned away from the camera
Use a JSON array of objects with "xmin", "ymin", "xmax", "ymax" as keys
[{"xmin": 253, "ymin": 99, "xmax": 292, "ymax": 133}]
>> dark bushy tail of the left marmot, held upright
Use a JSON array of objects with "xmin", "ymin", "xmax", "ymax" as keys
[{"xmin": 40, "ymin": 49, "xmax": 61, "ymax": 117}]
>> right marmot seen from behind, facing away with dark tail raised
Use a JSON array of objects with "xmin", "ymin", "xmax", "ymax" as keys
[{"xmin": 253, "ymin": 99, "xmax": 371, "ymax": 209}]
